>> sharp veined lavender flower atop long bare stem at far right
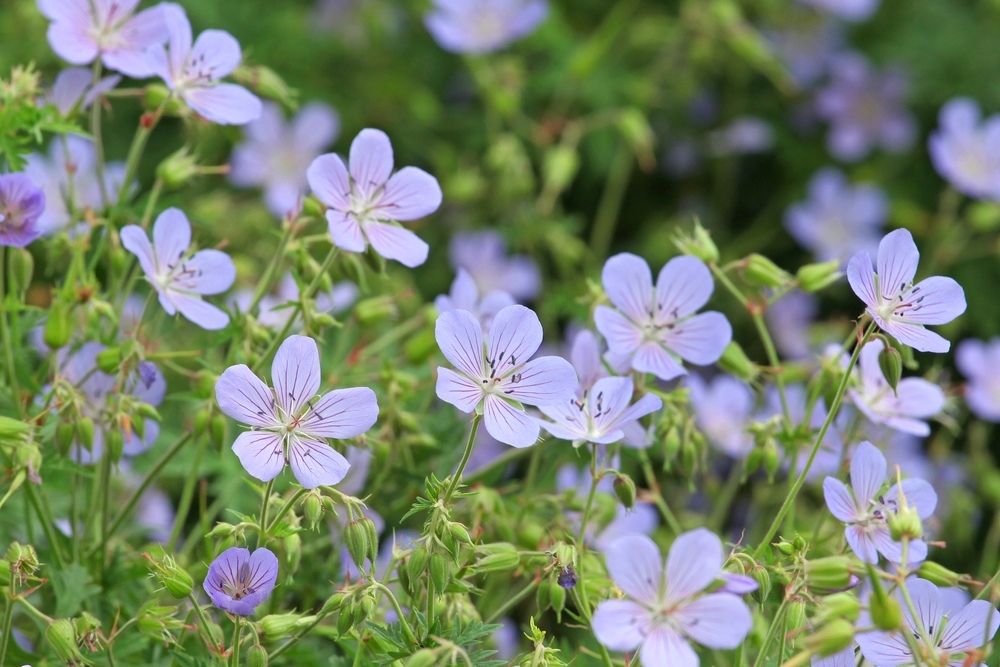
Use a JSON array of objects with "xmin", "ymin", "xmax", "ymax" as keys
[{"xmin": 847, "ymin": 229, "xmax": 965, "ymax": 352}]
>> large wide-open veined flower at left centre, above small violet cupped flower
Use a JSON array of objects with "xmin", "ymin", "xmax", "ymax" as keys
[{"xmin": 215, "ymin": 336, "xmax": 378, "ymax": 489}]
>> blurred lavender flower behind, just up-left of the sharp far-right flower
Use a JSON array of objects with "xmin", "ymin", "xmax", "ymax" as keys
[{"xmin": 785, "ymin": 168, "xmax": 889, "ymax": 262}]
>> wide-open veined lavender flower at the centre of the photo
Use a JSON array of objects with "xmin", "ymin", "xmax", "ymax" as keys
[{"xmin": 434, "ymin": 305, "xmax": 576, "ymax": 447}]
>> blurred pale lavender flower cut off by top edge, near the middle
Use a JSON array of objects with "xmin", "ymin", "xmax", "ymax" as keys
[{"xmin": 424, "ymin": 0, "xmax": 549, "ymax": 54}]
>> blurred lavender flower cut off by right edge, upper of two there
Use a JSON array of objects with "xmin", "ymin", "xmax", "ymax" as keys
[{"xmin": 928, "ymin": 97, "xmax": 1000, "ymax": 199}]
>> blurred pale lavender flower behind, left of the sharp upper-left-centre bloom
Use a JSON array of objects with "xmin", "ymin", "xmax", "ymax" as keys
[{"xmin": 229, "ymin": 102, "xmax": 340, "ymax": 217}]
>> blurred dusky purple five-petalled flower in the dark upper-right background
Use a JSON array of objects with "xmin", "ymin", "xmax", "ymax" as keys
[{"xmin": 816, "ymin": 53, "xmax": 916, "ymax": 162}]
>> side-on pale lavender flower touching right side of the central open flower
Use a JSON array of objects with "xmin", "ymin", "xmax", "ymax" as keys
[{"xmin": 536, "ymin": 377, "xmax": 663, "ymax": 447}]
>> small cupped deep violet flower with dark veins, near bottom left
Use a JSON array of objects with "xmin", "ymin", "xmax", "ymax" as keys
[{"xmin": 203, "ymin": 547, "xmax": 278, "ymax": 616}]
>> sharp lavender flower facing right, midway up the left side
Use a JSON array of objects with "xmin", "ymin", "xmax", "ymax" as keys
[{"xmin": 121, "ymin": 208, "xmax": 236, "ymax": 330}]
